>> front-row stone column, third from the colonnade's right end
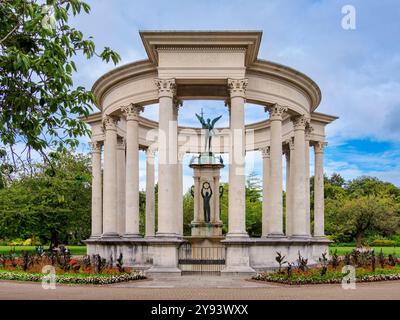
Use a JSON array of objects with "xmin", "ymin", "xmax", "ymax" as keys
[{"xmin": 266, "ymin": 104, "xmax": 287, "ymax": 237}]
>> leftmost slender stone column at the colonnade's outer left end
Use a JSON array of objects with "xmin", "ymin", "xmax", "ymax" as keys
[{"xmin": 91, "ymin": 141, "xmax": 103, "ymax": 239}]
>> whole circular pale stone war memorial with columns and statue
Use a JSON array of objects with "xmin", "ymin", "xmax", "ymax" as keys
[{"xmin": 85, "ymin": 31, "xmax": 336, "ymax": 275}]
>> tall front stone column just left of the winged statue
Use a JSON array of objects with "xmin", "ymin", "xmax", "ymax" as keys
[{"xmin": 155, "ymin": 79, "xmax": 178, "ymax": 237}]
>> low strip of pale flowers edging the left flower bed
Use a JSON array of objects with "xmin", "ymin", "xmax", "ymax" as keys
[{"xmin": 0, "ymin": 270, "xmax": 146, "ymax": 284}]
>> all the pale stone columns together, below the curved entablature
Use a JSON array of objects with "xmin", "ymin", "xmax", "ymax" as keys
[{"xmin": 91, "ymin": 79, "xmax": 324, "ymax": 240}]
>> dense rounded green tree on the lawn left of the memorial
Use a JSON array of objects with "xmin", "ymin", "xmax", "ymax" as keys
[{"xmin": 0, "ymin": 151, "xmax": 91, "ymax": 246}]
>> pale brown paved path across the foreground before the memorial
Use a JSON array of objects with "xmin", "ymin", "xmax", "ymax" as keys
[{"xmin": 0, "ymin": 276, "xmax": 400, "ymax": 300}]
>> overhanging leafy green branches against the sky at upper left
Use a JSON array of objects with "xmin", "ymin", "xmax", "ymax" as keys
[{"xmin": 0, "ymin": 0, "xmax": 120, "ymax": 170}]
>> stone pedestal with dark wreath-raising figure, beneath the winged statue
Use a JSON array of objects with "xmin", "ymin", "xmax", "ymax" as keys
[{"xmin": 189, "ymin": 152, "xmax": 224, "ymax": 237}]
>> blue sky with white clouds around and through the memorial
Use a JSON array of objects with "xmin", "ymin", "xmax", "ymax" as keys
[{"xmin": 71, "ymin": 0, "xmax": 400, "ymax": 190}]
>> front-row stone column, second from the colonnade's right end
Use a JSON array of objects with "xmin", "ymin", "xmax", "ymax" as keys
[{"xmin": 292, "ymin": 116, "xmax": 307, "ymax": 237}]
